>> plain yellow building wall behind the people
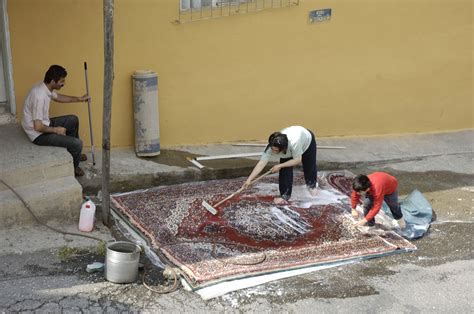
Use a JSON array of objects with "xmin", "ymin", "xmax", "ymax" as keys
[{"xmin": 8, "ymin": 0, "xmax": 474, "ymax": 146}]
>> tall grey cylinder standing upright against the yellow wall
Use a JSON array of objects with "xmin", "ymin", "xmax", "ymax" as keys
[{"xmin": 132, "ymin": 70, "xmax": 160, "ymax": 156}]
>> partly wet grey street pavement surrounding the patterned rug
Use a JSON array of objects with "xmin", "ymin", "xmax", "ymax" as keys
[{"xmin": 0, "ymin": 145, "xmax": 474, "ymax": 313}]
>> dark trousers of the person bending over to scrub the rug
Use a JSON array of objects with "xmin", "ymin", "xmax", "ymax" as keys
[{"xmin": 278, "ymin": 131, "xmax": 318, "ymax": 200}]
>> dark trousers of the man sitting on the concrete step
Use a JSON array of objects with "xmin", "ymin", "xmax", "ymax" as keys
[{"xmin": 33, "ymin": 115, "xmax": 82, "ymax": 169}]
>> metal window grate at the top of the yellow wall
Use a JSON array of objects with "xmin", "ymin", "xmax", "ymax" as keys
[{"xmin": 177, "ymin": 0, "xmax": 299, "ymax": 23}]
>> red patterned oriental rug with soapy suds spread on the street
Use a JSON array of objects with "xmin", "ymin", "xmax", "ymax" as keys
[{"xmin": 111, "ymin": 172, "xmax": 416, "ymax": 289}]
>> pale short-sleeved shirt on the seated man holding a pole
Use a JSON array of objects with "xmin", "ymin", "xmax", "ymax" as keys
[{"xmin": 21, "ymin": 82, "xmax": 58, "ymax": 142}]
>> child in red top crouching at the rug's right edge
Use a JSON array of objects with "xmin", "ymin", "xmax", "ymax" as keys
[{"xmin": 351, "ymin": 172, "xmax": 405, "ymax": 229}]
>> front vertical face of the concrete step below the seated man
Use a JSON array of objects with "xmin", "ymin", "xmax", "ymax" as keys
[{"xmin": 0, "ymin": 176, "xmax": 82, "ymax": 228}]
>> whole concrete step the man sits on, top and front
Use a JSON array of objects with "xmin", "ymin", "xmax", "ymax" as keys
[{"xmin": 0, "ymin": 123, "xmax": 82, "ymax": 227}]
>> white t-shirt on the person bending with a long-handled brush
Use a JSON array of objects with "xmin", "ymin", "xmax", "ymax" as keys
[{"xmin": 260, "ymin": 126, "xmax": 311, "ymax": 161}]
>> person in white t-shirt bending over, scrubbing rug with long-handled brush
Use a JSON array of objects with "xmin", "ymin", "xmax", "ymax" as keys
[{"xmin": 243, "ymin": 126, "xmax": 318, "ymax": 204}]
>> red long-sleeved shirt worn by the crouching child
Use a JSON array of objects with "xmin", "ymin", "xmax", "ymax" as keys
[{"xmin": 351, "ymin": 172, "xmax": 398, "ymax": 221}]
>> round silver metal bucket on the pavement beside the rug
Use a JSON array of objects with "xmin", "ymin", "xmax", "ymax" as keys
[{"xmin": 105, "ymin": 241, "xmax": 141, "ymax": 283}]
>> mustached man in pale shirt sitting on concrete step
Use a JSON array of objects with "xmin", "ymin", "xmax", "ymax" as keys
[{"xmin": 21, "ymin": 65, "xmax": 89, "ymax": 176}]
